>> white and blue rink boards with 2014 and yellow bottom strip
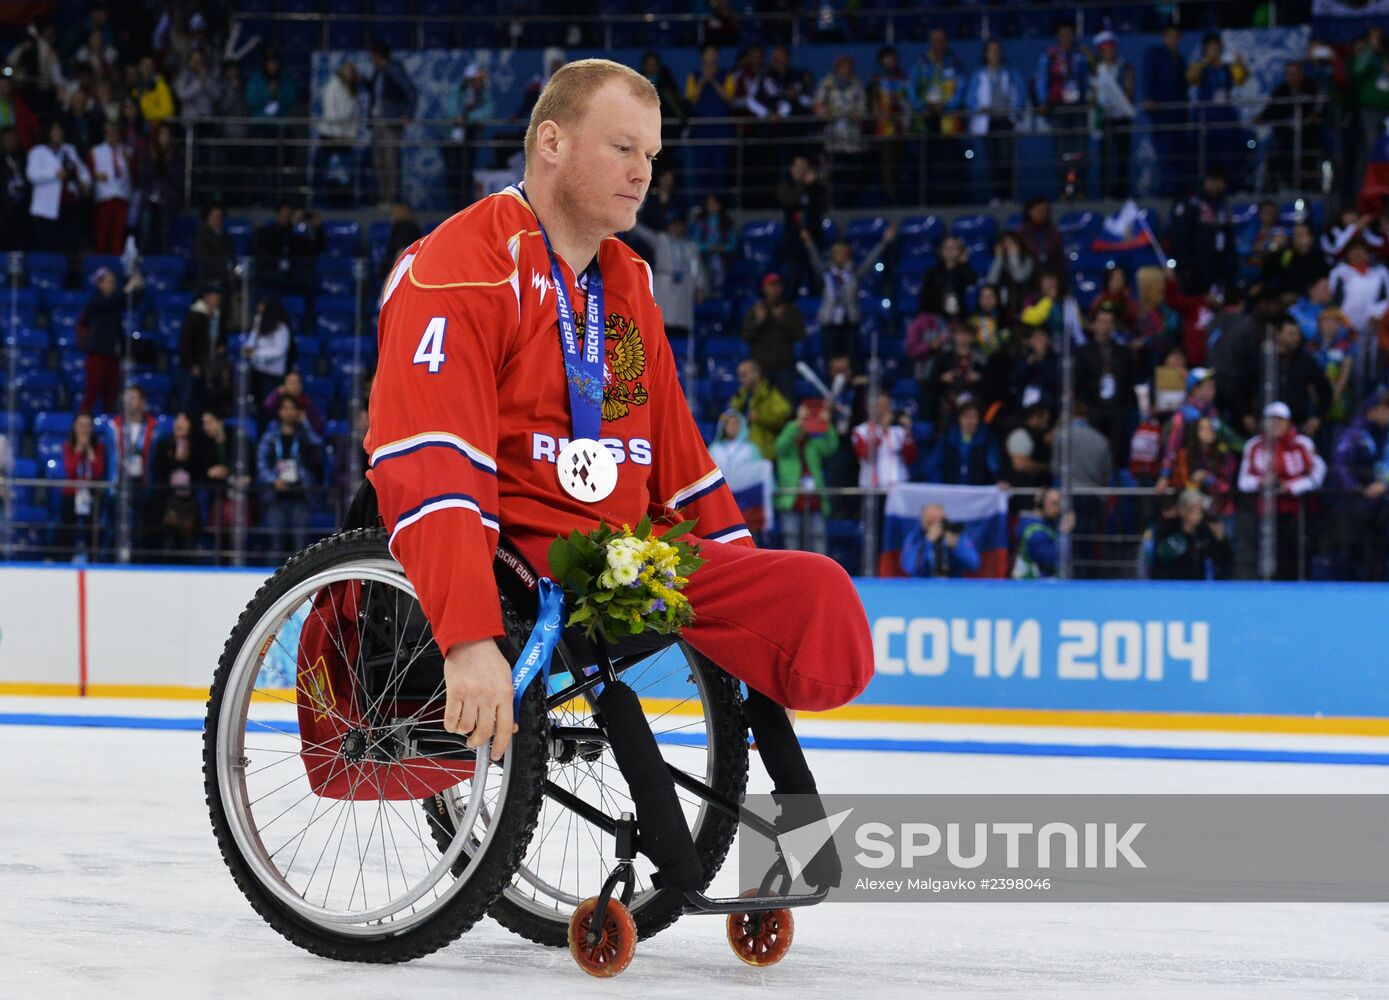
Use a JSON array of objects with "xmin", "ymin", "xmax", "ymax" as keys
[{"xmin": 0, "ymin": 567, "xmax": 1389, "ymax": 735}]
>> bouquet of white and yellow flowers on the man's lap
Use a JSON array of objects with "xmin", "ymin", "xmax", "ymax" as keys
[{"xmin": 550, "ymin": 517, "xmax": 707, "ymax": 639}]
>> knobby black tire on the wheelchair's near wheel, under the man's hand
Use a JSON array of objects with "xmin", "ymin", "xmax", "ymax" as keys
[{"xmin": 203, "ymin": 528, "xmax": 549, "ymax": 963}]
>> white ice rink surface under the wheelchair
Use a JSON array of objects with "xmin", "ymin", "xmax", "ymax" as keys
[{"xmin": 0, "ymin": 697, "xmax": 1389, "ymax": 1000}]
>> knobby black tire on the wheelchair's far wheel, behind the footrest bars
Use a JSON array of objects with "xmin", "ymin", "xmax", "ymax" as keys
[{"xmin": 424, "ymin": 643, "xmax": 747, "ymax": 947}]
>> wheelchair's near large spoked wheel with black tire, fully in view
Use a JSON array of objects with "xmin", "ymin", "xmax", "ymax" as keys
[{"xmin": 203, "ymin": 529, "xmax": 547, "ymax": 963}]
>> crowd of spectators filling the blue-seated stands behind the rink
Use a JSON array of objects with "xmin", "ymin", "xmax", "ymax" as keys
[{"xmin": 0, "ymin": 4, "xmax": 1389, "ymax": 579}]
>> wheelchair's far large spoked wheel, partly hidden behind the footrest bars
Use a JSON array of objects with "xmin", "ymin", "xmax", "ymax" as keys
[{"xmin": 426, "ymin": 642, "xmax": 747, "ymax": 947}]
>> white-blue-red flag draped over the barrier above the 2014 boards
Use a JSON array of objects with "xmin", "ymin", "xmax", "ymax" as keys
[{"xmin": 878, "ymin": 483, "xmax": 1008, "ymax": 578}]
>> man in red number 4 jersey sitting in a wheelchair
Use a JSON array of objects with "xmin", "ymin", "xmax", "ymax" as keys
[{"xmin": 365, "ymin": 60, "xmax": 872, "ymax": 792}]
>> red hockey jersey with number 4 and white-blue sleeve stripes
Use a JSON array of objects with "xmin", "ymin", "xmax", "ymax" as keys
[{"xmin": 365, "ymin": 188, "xmax": 751, "ymax": 651}]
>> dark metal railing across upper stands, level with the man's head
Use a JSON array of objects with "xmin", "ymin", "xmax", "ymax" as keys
[{"xmin": 170, "ymin": 97, "xmax": 1340, "ymax": 210}]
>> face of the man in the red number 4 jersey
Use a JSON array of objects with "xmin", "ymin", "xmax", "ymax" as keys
[{"xmin": 557, "ymin": 79, "xmax": 661, "ymax": 233}]
